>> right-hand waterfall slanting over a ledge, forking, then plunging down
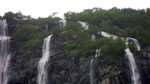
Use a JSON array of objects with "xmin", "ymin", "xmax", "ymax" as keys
[{"xmin": 101, "ymin": 32, "xmax": 141, "ymax": 84}]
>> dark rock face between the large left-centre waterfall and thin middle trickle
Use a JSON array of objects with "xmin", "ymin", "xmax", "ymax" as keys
[{"xmin": 48, "ymin": 35, "xmax": 92, "ymax": 84}]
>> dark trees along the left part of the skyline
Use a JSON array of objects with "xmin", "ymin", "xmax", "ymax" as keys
[{"xmin": 0, "ymin": 11, "xmax": 60, "ymax": 25}]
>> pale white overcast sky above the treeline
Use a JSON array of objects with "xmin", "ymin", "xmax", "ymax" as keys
[{"xmin": 0, "ymin": 0, "xmax": 150, "ymax": 18}]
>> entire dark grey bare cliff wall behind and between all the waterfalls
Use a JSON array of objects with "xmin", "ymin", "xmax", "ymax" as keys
[{"xmin": 6, "ymin": 25, "xmax": 150, "ymax": 84}]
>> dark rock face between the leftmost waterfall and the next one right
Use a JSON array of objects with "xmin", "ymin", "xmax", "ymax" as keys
[{"xmin": 9, "ymin": 36, "xmax": 42, "ymax": 84}]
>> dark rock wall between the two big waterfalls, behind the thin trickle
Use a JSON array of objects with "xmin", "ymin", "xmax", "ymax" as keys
[{"xmin": 41, "ymin": 35, "xmax": 125, "ymax": 84}]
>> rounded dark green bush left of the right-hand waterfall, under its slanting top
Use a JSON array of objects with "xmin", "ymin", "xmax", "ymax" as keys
[{"xmin": 100, "ymin": 39, "xmax": 126, "ymax": 60}]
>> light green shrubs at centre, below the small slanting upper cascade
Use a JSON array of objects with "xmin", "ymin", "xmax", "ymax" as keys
[{"xmin": 64, "ymin": 22, "xmax": 95, "ymax": 55}]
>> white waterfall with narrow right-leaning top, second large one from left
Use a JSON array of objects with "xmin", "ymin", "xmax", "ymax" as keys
[{"xmin": 37, "ymin": 35, "xmax": 52, "ymax": 84}]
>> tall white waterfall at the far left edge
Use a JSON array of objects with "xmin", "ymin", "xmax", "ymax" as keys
[{"xmin": 0, "ymin": 20, "xmax": 10, "ymax": 84}]
